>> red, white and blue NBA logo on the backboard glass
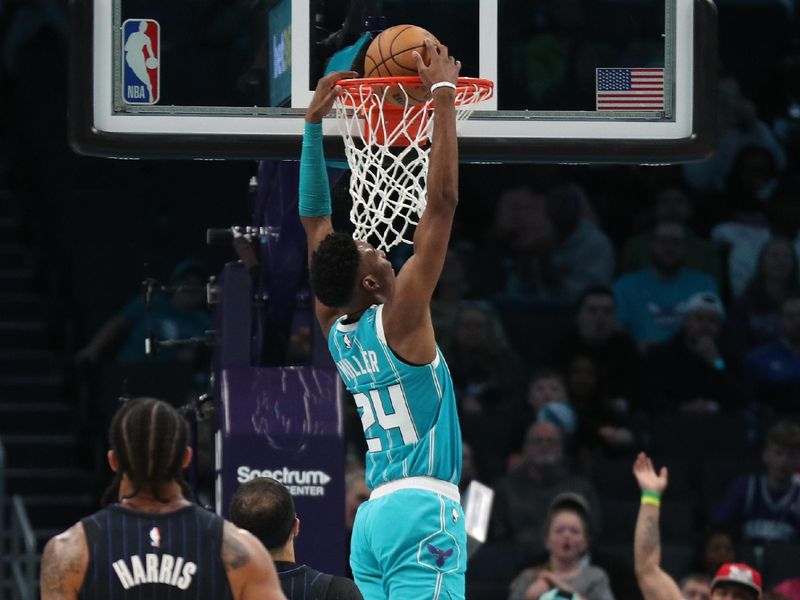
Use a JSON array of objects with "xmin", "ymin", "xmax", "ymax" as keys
[{"xmin": 122, "ymin": 19, "xmax": 161, "ymax": 104}]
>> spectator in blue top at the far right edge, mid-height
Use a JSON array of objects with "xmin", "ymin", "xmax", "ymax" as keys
[{"xmin": 747, "ymin": 292, "xmax": 800, "ymax": 414}]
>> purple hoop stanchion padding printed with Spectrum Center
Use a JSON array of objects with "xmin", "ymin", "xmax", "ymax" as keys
[{"xmin": 215, "ymin": 367, "xmax": 346, "ymax": 575}]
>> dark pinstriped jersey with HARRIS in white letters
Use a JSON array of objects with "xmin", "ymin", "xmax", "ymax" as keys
[{"xmin": 80, "ymin": 505, "xmax": 233, "ymax": 600}]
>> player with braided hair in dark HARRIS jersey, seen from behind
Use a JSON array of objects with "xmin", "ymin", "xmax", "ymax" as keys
[{"xmin": 40, "ymin": 398, "xmax": 286, "ymax": 600}]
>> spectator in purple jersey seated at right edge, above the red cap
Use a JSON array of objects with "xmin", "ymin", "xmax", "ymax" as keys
[{"xmin": 712, "ymin": 421, "xmax": 800, "ymax": 543}]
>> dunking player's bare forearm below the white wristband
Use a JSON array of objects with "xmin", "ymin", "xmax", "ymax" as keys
[{"xmin": 427, "ymin": 88, "xmax": 458, "ymax": 209}]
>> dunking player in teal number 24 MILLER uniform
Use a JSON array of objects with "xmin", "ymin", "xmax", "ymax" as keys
[{"xmin": 300, "ymin": 40, "xmax": 467, "ymax": 600}]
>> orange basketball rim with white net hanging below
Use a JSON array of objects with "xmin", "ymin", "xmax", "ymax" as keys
[{"xmin": 334, "ymin": 77, "xmax": 494, "ymax": 251}]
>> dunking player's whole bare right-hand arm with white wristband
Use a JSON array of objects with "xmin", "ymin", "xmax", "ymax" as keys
[{"xmin": 384, "ymin": 40, "xmax": 461, "ymax": 362}]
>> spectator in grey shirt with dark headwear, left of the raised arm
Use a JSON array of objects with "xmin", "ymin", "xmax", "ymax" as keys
[{"xmin": 509, "ymin": 492, "xmax": 614, "ymax": 600}]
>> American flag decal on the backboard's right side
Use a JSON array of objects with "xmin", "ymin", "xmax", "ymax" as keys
[{"xmin": 596, "ymin": 68, "xmax": 664, "ymax": 111}]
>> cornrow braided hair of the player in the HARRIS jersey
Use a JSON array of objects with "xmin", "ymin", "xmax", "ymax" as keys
[{"xmin": 103, "ymin": 398, "xmax": 192, "ymax": 504}]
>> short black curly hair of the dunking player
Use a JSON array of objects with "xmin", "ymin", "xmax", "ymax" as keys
[{"xmin": 310, "ymin": 232, "xmax": 361, "ymax": 308}]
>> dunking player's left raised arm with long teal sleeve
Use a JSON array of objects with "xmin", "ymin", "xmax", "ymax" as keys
[{"xmin": 299, "ymin": 71, "xmax": 357, "ymax": 334}]
